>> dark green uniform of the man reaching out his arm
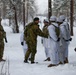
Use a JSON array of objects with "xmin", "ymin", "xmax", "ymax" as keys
[{"xmin": 24, "ymin": 22, "xmax": 48, "ymax": 62}]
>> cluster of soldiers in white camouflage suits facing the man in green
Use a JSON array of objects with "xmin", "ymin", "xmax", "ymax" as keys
[{"xmin": 43, "ymin": 15, "xmax": 72, "ymax": 67}]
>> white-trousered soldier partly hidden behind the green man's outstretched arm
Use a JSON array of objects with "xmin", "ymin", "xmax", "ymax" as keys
[{"xmin": 41, "ymin": 19, "xmax": 50, "ymax": 61}]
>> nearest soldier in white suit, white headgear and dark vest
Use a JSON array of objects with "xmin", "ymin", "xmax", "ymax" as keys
[{"xmin": 48, "ymin": 16, "xmax": 60, "ymax": 67}]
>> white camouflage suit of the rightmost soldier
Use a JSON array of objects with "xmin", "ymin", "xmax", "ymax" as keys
[{"xmin": 60, "ymin": 21, "xmax": 71, "ymax": 62}]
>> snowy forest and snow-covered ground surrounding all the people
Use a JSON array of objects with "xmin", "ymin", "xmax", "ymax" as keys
[{"xmin": 0, "ymin": 0, "xmax": 76, "ymax": 75}]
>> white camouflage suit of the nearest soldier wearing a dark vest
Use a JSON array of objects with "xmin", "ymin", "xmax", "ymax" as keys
[{"xmin": 48, "ymin": 23, "xmax": 59, "ymax": 65}]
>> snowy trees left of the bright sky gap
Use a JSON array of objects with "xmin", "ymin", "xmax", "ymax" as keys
[{"xmin": 0, "ymin": 0, "xmax": 37, "ymax": 33}]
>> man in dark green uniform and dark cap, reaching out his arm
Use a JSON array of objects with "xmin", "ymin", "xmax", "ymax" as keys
[{"xmin": 21, "ymin": 17, "xmax": 48, "ymax": 64}]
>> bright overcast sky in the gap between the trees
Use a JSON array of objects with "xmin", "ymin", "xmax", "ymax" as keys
[{"xmin": 36, "ymin": 0, "xmax": 48, "ymax": 13}]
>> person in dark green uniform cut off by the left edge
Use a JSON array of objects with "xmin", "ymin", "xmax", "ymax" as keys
[{"xmin": 0, "ymin": 18, "xmax": 7, "ymax": 62}]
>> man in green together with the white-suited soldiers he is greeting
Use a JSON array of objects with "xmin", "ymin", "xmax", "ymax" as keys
[{"xmin": 21, "ymin": 15, "xmax": 72, "ymax": 67}]
